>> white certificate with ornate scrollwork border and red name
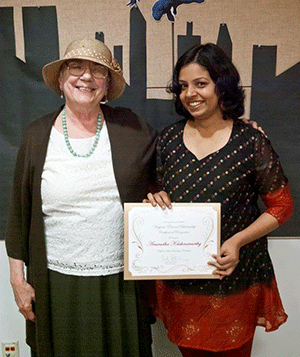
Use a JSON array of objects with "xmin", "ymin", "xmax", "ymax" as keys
[{"xmin": 124, "ymin": 203, "xmax": 221, "ymax": 280}]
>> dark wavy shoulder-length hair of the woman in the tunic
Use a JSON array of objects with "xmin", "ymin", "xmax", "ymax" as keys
[{"xmin": 167, "ymin": 43, "xmax": 245, "ymax": 120}]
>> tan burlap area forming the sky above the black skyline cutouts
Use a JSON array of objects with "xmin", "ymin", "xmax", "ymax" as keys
[{"xmin": 0, "ymin": 0, "xmax": 300, "ymax": 111}]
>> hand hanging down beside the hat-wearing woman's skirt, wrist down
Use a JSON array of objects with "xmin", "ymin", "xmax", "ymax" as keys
[{"xmin": 11, "ymin": 280, "xmax": 35, "ymax": 322}]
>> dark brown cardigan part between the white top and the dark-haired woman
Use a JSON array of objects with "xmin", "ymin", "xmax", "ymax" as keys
[{"xmin": 101, "ymin": 105, "xmax": 158, "ymax": 203}]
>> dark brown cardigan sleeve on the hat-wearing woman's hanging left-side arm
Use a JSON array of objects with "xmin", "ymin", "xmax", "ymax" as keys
[{"xmin": 5, "ymin": 108, "xmax": 62, "ymax": 265}]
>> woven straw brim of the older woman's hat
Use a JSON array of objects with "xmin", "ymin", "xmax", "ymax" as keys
[{"xmin": 42, "ymin": 55, "xmax": 126, "ymax": 101}]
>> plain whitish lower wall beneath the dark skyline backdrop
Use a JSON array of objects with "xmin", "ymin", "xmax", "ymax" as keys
[{"xmin": 0, "ymin": 239, "xmax": 300, "ymax": 357}]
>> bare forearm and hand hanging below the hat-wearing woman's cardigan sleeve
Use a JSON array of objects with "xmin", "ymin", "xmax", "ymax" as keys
[{"xmin": 9, "ymin": 257, "xmax": 35, "ymax": 322}]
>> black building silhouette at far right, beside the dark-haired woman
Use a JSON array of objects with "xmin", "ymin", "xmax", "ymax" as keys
[{"xmin": 251, "ymin": 46, "xmax": 300, "ymax": 236}]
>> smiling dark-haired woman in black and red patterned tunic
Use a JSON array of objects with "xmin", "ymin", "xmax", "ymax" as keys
[{"xmin": 148, "ymin": 44, "xmax": 293, "ymax": 357}]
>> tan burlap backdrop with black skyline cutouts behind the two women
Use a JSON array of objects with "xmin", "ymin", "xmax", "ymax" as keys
[{"xmin": 0, "ymin": 0, "xmax": 300, "ymax": 239}]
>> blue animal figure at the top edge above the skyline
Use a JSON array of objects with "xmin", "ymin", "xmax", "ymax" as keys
[{"xmin": 152, "ymin": 0, "xmax": 205, "ymax": 21}]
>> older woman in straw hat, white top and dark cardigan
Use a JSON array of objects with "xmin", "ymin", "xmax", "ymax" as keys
[{"xmin": 6, "ymin": 39, "xmax": 157, "ymax": 357}]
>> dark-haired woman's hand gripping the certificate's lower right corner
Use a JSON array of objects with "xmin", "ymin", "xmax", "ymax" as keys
[{"xmin": 208, "ymin": 238, "xmax": 240, "ymax": 279}]
